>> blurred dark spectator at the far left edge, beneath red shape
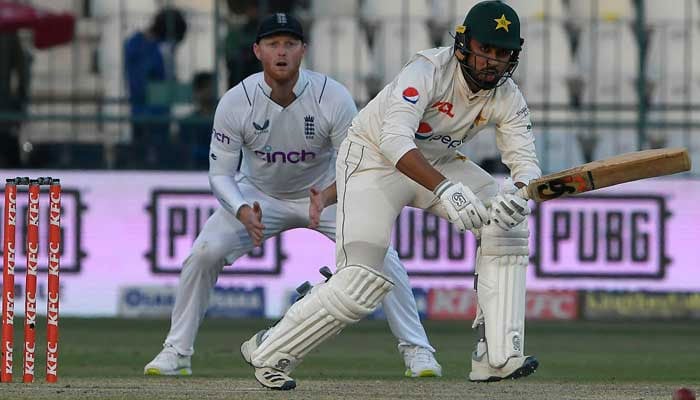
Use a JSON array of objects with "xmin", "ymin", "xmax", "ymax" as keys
[{"xmin": 0, "ymin": 32, "xmax": 29, "ymax": 168}]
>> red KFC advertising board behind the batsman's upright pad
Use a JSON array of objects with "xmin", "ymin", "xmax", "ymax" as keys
[{"xmin": 427, "ymin": 288, "xmax": 578, "ymax": 320}]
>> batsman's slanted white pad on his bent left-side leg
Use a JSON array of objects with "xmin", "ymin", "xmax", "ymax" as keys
[{"xmin": 251, "ymin": 265, "xmax": 394, "ymax": 372}]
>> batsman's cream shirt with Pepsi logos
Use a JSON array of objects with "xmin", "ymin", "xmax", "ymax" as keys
[{"xmin": 348, "ymin": 47, "xmax": 542, "ymax": 183}]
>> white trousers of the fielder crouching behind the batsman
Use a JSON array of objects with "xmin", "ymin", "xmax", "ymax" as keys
[{"xmin": 165, "ymin": 173, "xmax": 435, "ymax": 355}]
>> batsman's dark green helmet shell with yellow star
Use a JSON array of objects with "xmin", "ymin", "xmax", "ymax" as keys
[{"xmin": 457, "ymin": 0, "xmax": 521, "ymax": 50}]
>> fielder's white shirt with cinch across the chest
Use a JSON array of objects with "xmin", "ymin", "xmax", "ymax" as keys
[{"xmin": 209, "ymin": 69, "xmax": 357, "ymax": 210}]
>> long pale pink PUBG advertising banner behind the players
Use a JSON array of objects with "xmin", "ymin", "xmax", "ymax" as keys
[{"xmin": 0, "ymin": 170, "xmax": 700, "ymax": 318}]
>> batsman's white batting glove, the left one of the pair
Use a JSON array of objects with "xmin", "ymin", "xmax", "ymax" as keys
[{"xmin": 433, "ymin": 179, "xmax": 489, "ymax": 232}]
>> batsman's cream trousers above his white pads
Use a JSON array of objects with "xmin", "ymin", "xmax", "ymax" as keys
[{"xmin": 336, "ymin": 139, "xmax": 498, "ymax": 270}]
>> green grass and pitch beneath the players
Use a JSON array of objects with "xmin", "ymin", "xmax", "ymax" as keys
[{"xmin": 0, "ymin": 318, "xmax": 700, "ymax": 400}]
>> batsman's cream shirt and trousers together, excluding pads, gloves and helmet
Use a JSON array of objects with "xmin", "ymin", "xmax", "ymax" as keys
[{"xmin": 336, "ymin": 47, "xmax": 541, "ymax": 268}]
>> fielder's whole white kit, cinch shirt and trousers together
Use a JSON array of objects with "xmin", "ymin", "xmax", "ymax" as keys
[{"xmin": 165, "ymin": 70, "xmax": 433, "ymax": 355}]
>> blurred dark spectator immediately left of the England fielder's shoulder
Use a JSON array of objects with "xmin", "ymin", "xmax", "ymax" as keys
[{"xmin": 180, "ymin": 72, "xmax": 217, "ymax": 170}]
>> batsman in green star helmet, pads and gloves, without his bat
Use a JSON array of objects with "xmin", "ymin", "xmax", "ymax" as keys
[{"xmin": 241, "ymin": 1, "xmax": 541, "ymax": 389}]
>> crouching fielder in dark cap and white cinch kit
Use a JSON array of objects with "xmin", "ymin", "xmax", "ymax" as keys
[{"xmin": 144, "ymin": 14, "xmax": 442, "ymax": 377}]
